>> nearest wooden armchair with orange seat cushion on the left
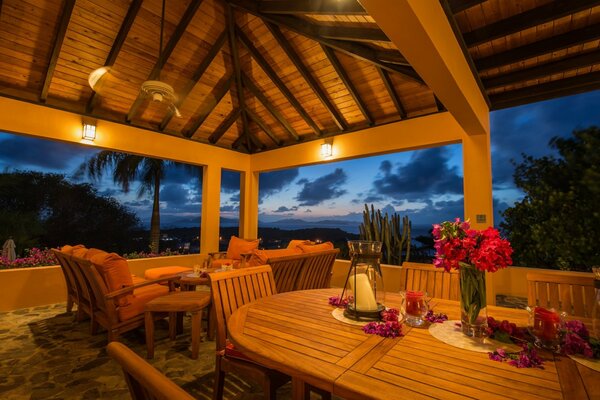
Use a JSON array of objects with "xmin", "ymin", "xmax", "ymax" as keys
[{"xmin": 71, "ymin": 257, "xmax": 180, "ymax": 342}]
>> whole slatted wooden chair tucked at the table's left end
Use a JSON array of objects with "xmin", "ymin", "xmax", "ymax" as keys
[{"xmin": 210, "ymin": 265, "xmax": 290, "ymax": 399}]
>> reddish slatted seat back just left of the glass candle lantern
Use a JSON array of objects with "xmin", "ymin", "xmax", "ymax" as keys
[{"xmin": 294, "ymin": 249, "xmax": 340, "ymax": 290}]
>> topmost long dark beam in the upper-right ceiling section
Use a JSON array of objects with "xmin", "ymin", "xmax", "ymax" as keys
[{"xmin": 463, "ymin": 0, "xmax": 600, "ymax": 47}]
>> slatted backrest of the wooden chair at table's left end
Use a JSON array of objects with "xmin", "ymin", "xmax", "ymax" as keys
[{"xmin": 209, "ymin": 265, "xmax": 277, "ymax": 351}]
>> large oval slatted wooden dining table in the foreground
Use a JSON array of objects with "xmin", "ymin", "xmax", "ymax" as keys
[{"xmin": 227, "ymin": 289, "xmax": 600, "ymax": 400}]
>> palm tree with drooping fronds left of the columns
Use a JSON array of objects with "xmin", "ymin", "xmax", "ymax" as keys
[{"xmin": 79, "ymin": 150, "xmax": 197, "ymax": 253}]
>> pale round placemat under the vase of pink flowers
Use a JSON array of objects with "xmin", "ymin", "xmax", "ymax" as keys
[{"xmin": 429, "ymin": 320, "xmax": 521, "ymax": 353}]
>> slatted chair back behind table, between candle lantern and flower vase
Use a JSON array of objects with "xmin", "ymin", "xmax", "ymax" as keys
[{"xmin": 400, "ymin": 262, "xmax": 460, "ymax": 300}]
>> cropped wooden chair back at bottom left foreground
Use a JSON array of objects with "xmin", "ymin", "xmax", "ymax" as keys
[{"xmin": 107, "ymin": 342, "xmax": 194, "ymax": 400}]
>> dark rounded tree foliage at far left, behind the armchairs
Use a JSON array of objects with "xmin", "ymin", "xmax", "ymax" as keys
[{"xmin": 0, "ymin": 171, "xmax": 139, "ymax": 253}]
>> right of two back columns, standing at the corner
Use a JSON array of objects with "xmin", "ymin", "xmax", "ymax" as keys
[{"xmin": 239, "ymin": 171, "xmax": 259, "ymax": 239}]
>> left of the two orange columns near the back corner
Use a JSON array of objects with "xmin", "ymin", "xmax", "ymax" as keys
[{"xmin": 200, "ymin": 165, "xmax": 221, "ymax": 253}]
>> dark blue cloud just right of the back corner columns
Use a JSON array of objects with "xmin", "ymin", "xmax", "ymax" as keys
[{"xmin": 296, "ymin": 168, "xmax": 348, "ymax": 206}]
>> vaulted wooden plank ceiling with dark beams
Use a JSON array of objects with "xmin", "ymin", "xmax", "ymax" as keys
[{"xmin": 0, "ymin": 0, "xmax": 600, "ymax": 153}]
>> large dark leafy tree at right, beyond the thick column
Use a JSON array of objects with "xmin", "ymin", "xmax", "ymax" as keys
[{"xmin": 501, "ymin": 127, "xmax": 600, "ymax": 271}]
